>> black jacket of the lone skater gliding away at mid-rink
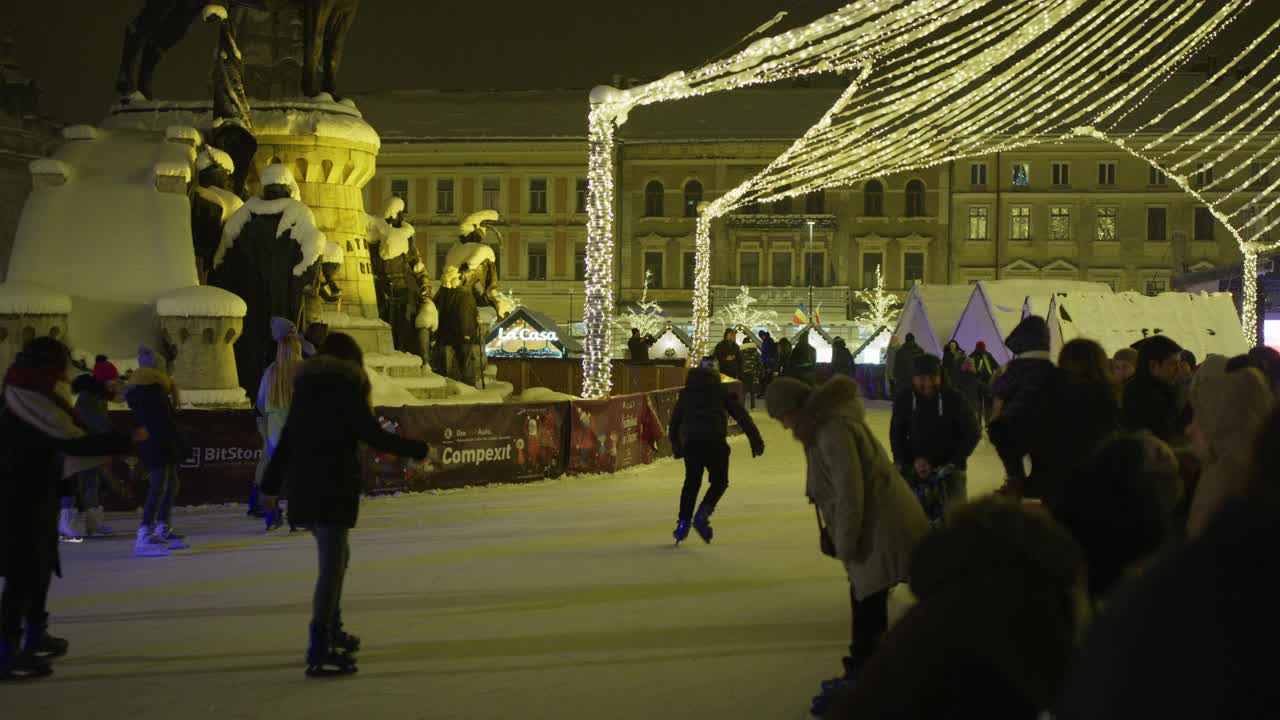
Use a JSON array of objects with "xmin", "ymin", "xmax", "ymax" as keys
[{"xmin": 668, "ymin": 368, "xmax": 764, "ymax": 457}]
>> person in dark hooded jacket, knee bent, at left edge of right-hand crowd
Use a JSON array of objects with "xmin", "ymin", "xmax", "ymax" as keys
[{"xmin": 987, "ymin": 315, "xmax": 1053, "ymax": 497}]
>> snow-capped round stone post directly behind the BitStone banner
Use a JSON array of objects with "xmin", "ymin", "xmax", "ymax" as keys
[{"xmin": 156, "ymin": 286, "xmax": 248, "ymax": 407}]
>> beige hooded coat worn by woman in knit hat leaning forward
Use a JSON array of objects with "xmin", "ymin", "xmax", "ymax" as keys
[{"xmin": 795, "ymin": 375, "xmax": 929, "ymax": 600}]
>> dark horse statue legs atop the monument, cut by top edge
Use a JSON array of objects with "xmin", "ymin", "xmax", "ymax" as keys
[{"xmin": 115, "ymin": 0, "xmax": 360, "ymax": 100}]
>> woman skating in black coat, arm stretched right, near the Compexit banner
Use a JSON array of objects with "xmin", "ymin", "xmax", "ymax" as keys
[{"xmin": 262, "ymin": 333, "xmax": 428, "ymax": 676}]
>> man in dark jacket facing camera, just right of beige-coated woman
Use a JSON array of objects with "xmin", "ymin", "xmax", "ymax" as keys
[{"xmin": 890, "ymin": 355, "xmax": 982, "ymax": 502}]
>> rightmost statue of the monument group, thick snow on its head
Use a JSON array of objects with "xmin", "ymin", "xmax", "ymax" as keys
[{"xmin": 435, "ymin": 210, "xmax": 511, "ymax": 384}]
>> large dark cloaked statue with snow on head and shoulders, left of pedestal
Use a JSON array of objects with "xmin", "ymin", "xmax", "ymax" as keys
[{"xmin": 210, "ymin": 164, "xmax": 325, "ymax": 393}]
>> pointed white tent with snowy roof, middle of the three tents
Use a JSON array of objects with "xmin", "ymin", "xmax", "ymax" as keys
[{"xmin": 943, "ymin": 279, "xmax": 1111, "ymax": 365}]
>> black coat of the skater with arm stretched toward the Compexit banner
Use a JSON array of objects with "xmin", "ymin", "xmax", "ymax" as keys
[{"xmin": 262, "ymin": 355, "xmax": 428, "ymax": 528}]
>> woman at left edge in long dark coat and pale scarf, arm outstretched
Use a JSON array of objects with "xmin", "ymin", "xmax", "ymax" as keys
[{"xmin": 0, "ymin": 337, "xmax": 129, "ymax": 679}]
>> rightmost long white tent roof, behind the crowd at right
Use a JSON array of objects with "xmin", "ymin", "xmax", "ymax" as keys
[{"xmin": 1048, "ymin": 292, "xmax": 1249, "ymax": 360}]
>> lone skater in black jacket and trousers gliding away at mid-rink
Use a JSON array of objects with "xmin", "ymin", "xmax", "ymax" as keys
[{"xmin": 668, "ymin": 357, "xmax": 764, "ymax": 544}]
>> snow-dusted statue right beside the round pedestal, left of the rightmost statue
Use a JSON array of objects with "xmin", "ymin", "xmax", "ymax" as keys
[{"xmin": 366, "ymin": 195, "xmax": 438, "ymax": 359}]
